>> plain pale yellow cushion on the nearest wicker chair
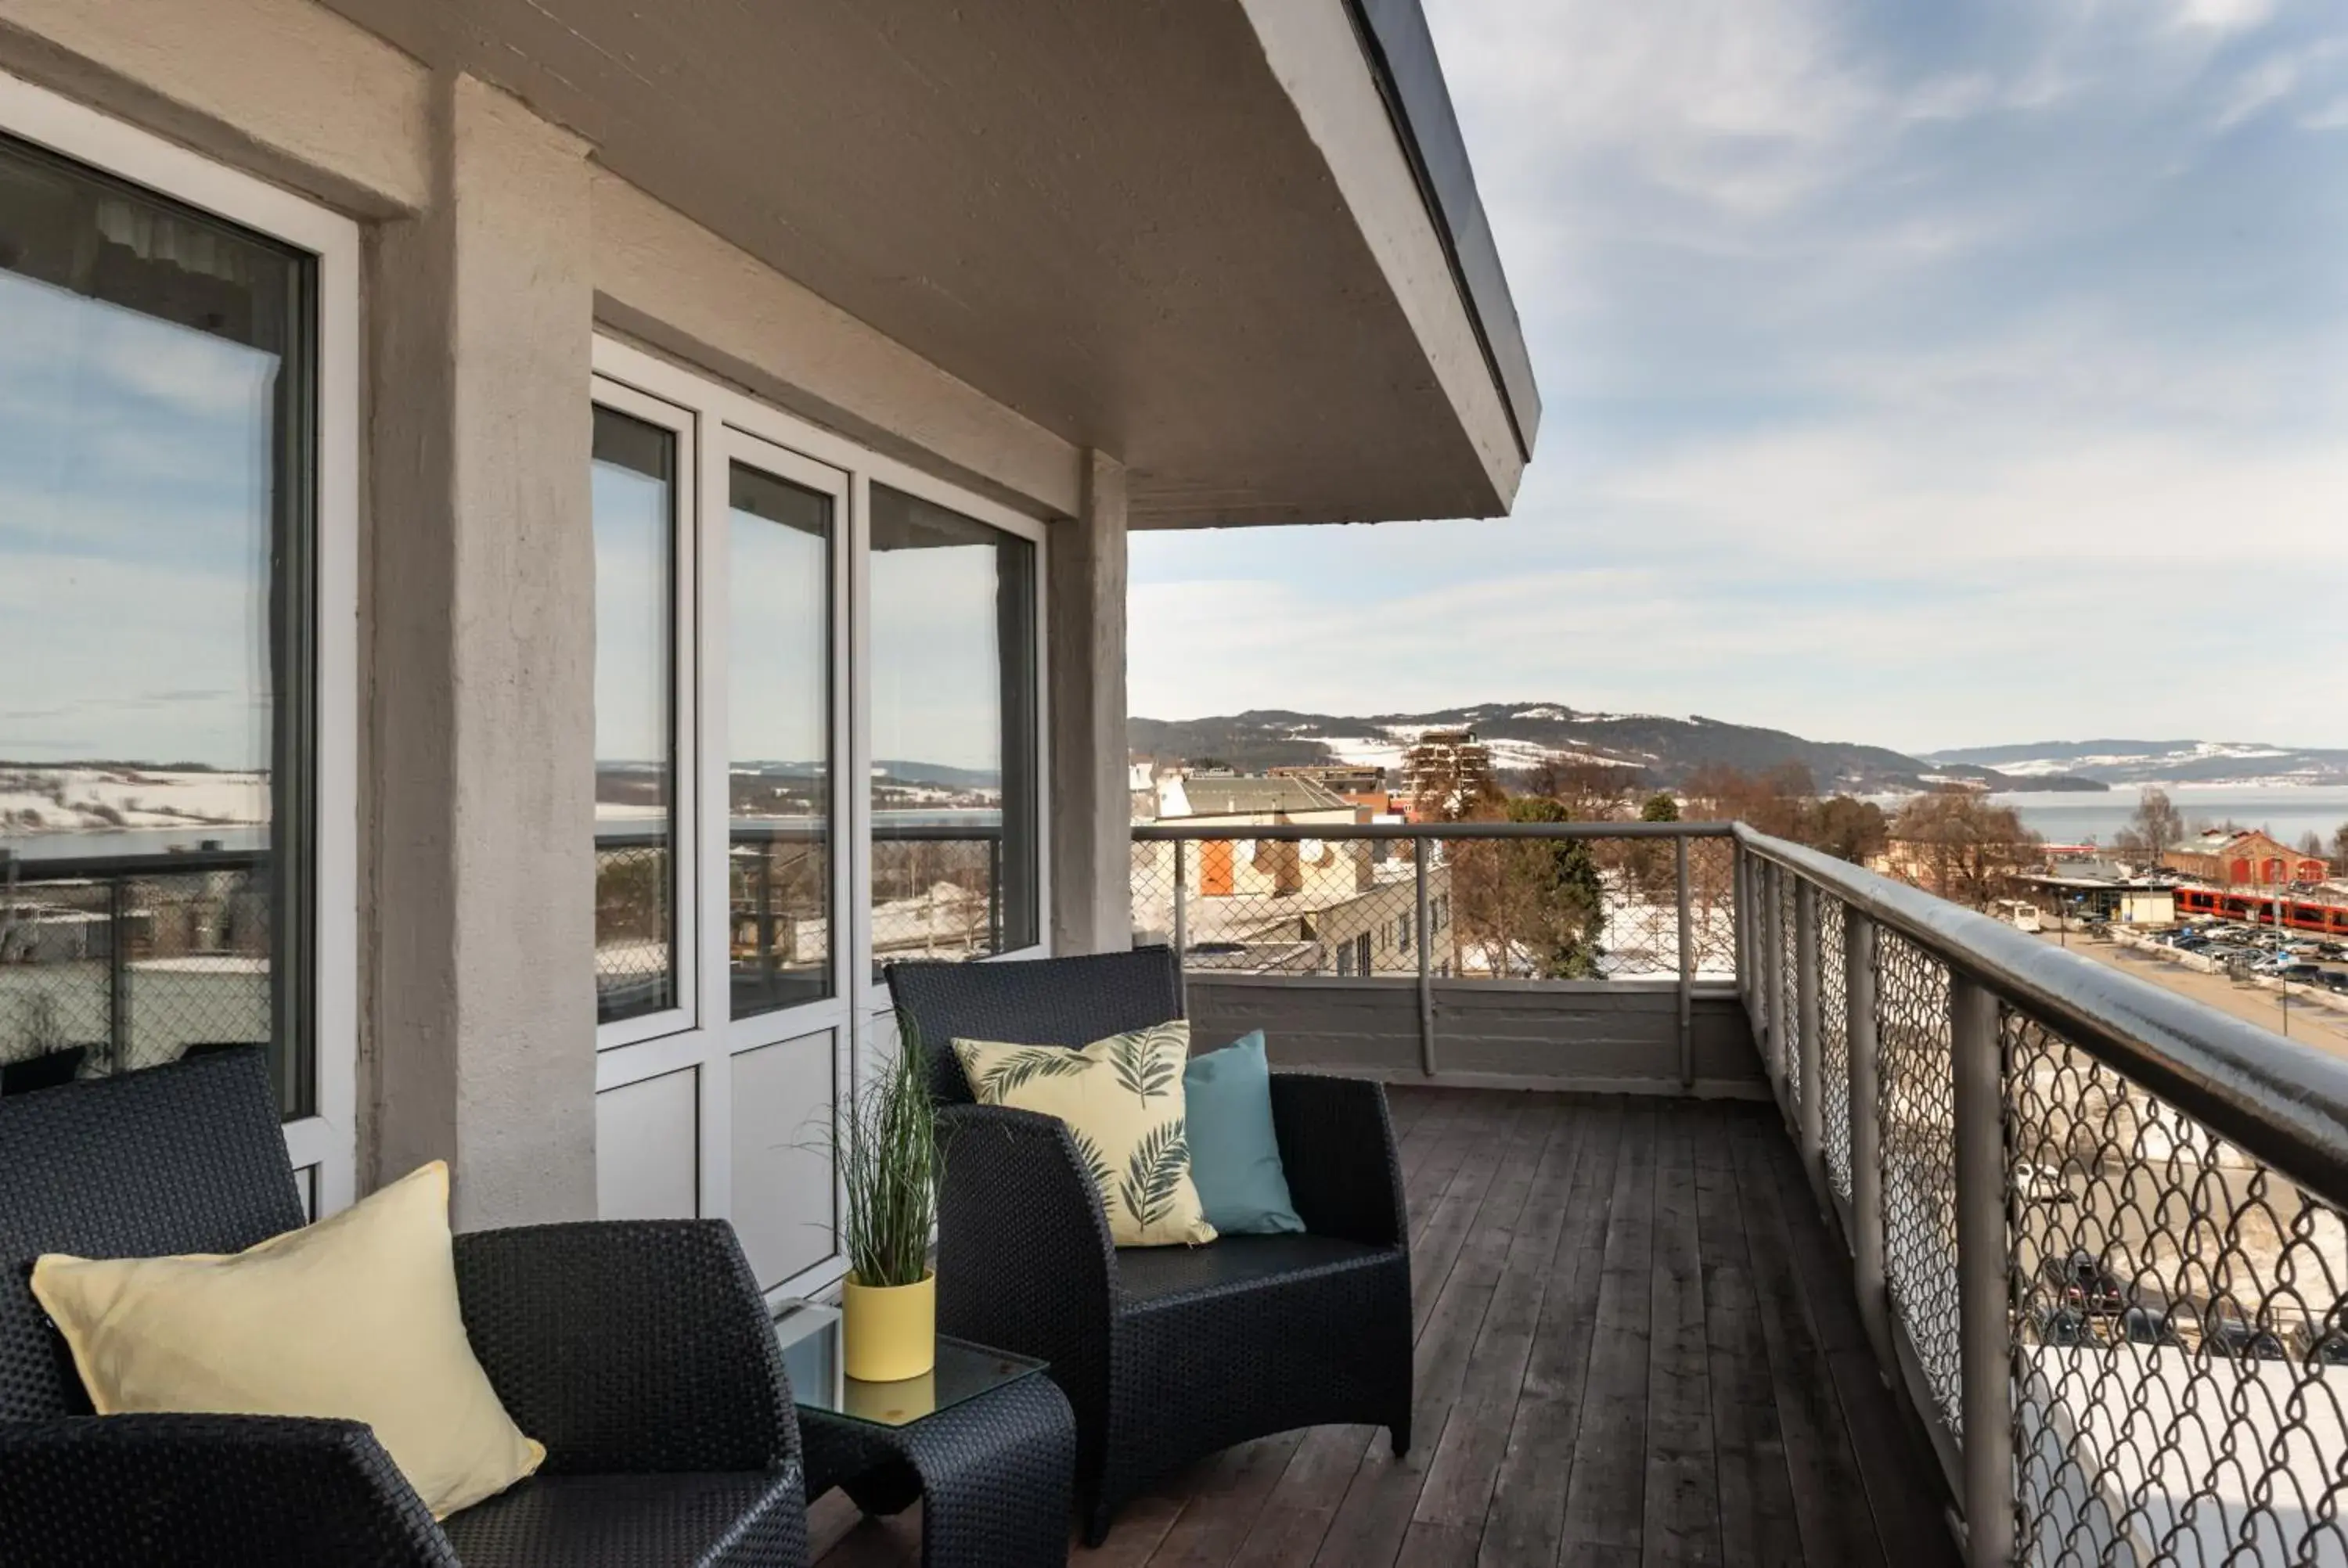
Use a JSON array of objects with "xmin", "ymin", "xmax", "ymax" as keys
[{"xmin": 33, "ymin": 1160, "xmax": 547, "ymax": 1519}]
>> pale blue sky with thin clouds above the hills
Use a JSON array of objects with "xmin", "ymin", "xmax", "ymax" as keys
[{"xmin": 1129, "ymin": 0, "xmax": 2348, "ymax": 749}]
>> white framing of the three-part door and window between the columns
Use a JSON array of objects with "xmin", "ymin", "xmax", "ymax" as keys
[{"xmin": 592, "ymin": 333, "xmax": 1052, "ymax": 1303}]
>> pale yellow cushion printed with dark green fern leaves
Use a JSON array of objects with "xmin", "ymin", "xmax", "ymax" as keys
[{"xmin": 946, "ymin": 1021, "xmax": 1214, "ymax": 1246}]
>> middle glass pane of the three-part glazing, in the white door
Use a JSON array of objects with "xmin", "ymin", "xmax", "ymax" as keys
[{"xmin": 726, "ymin": 462, "xmax": 831, "ymax": 1019}]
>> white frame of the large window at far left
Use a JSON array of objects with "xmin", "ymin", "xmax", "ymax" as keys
[{"xmin": 0, "ymin": 70, "xmax": 359, "ymax": 1214}]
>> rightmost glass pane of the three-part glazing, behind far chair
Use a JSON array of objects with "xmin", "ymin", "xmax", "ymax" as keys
[{"xmin": 871, "ymin": 484, "xmax": 1038, "ymax": 974}]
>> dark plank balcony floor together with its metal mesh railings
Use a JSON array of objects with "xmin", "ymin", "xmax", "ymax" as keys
[{"xmin": 817, "ymin": 824, "xmax": 2348, "ymax": 1563}]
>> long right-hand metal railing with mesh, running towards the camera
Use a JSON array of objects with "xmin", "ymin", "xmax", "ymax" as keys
[{"xmin": 1733, "ymin": 826, "xmax": 2348, "ymax": 1563}]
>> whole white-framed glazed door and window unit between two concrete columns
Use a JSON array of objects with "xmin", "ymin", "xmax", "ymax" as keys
[{"xmin": 589, "ymin": 343, "xmax": 1043, "ymax": 1293}]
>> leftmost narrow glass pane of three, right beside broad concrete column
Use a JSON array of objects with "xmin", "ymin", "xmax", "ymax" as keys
[{"xmin": 592, "ymin": 408, "xmax": 679, "ymax": 1023}]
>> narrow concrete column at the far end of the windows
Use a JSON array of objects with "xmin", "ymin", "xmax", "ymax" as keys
[{"xmin": 1047, "ymin": 453, "xmax": 1134, "ymax": 953}]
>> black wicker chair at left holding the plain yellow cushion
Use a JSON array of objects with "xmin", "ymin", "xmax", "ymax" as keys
[{"xmin": 0, "ymin": 1049, "xmax": 808, "ymax": 1568}]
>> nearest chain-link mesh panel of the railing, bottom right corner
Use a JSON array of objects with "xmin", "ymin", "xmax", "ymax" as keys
[{"xmin": 2003, "ymin": 1009, "xmax": 2348, "ymax": 1563}]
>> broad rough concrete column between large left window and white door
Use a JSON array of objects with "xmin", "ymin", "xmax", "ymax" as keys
[{"xmin": 362, "ymin": 75, "xmax": 596, "ymax": 1228}]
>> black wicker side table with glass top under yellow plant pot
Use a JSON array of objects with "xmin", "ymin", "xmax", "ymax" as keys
[{"xmin": 775, "ymin": 1307, "xmax": 1075, "ymax": 1568}]
